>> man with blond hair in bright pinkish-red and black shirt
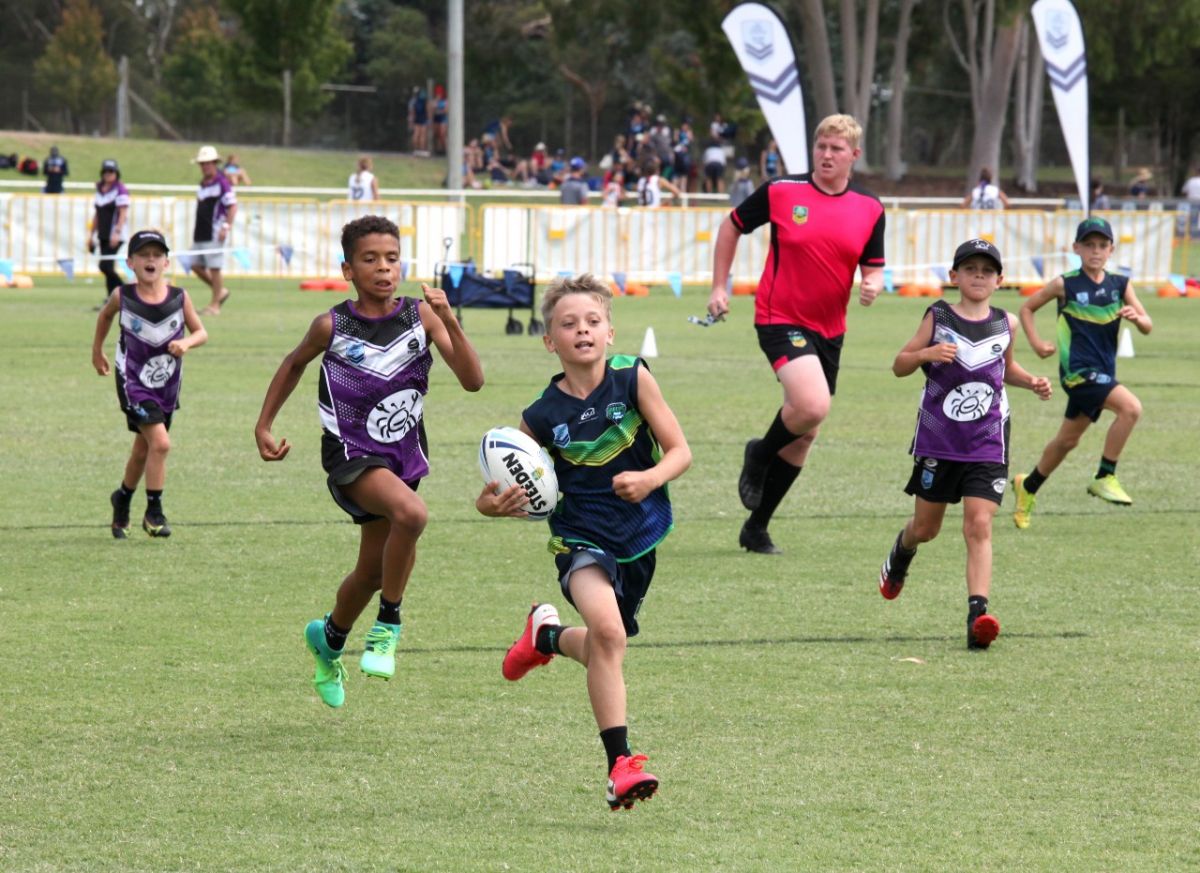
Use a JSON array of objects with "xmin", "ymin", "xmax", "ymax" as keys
[{"xmin": 708, "ymin": 115, "xmax": 884, "ymax": 554}]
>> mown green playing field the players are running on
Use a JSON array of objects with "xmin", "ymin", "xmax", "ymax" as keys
[{"xmin": 0, "ymin": 281, "xmax": 1200, "ymax": 873}]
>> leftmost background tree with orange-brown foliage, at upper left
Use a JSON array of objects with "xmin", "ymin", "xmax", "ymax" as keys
[{"xmin": 34, "ymin": 0, "xmax": 116, "ymax": 133}]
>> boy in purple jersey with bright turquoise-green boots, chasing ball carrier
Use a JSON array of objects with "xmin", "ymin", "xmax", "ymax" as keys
[{"xmin": 254, "ymin": 216, "xmax": 484, "ymax": 706}]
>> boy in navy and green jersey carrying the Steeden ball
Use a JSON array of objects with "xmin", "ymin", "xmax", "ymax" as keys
[{"xmin": 475, "ymin": 275, "xmax": 691, "ymax": 809}]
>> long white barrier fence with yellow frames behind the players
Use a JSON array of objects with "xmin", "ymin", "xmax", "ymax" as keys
[{"xmin": 0, "ymin": 194, "xmax": 1190, "ymax": 285}]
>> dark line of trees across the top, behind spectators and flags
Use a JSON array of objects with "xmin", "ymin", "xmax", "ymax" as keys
[{"xmin": 9, "ymin": 0, "xmax": 1200, "ymax": 191}]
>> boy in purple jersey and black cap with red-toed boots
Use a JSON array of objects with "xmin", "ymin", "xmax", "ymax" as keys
[{"xmin": 880, "ymin": 240, "xmax": 1051, "ymax": 649}]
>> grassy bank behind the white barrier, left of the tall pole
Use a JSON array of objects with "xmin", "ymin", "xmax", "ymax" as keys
[{"xmin": 0, "ymin": 131, "xmax": 445, "ymax": 193}]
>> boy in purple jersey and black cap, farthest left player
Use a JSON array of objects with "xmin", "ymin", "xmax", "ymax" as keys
[{"xmin": 91, "ymin": 230, "xmax": 209, "ymax": 540}]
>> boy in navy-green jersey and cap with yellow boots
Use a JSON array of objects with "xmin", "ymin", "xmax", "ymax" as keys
[{"xmin": 1013, "ymin": 218, "xmax": 1154, "ymax": 529}]
